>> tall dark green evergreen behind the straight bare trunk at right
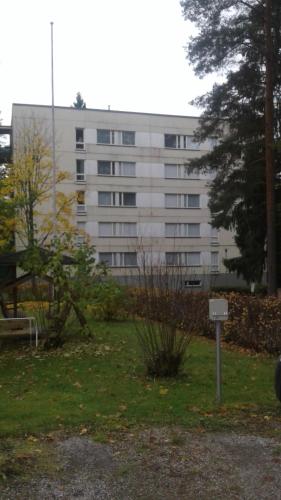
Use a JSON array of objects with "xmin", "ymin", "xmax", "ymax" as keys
[{"xmin": 181, "ymin": 0, "xmax": 281, "ymax": 283}]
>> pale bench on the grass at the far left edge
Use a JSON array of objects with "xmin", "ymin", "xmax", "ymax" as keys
[{"xmin": 0, "ymin": 316, "xmax": 38, "ymax": 347}]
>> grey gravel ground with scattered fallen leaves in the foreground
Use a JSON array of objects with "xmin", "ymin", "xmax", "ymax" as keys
[{"xmin": 0, "ymin": 428, "xmax": 281, "ymax": 500}]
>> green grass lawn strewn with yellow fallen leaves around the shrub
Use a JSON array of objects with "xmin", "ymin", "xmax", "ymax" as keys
[{"xmin": 0, "ymin": 322, "xmax": 281, "ymax": 437}]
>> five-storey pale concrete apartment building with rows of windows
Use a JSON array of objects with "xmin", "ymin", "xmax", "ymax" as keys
[{"xmin": 12, "ymin": 104, "xmax": 238, "ymax": 287}]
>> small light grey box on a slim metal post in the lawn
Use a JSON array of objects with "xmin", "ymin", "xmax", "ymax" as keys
[{"xmin": 209, "ymin": 299, "xmax": 228, "ymax": 404}]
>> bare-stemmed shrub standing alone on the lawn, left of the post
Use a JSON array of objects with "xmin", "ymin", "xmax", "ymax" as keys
[{"xmin": 135, "ymin": 264, "xmax": 199, "ymax": 377}]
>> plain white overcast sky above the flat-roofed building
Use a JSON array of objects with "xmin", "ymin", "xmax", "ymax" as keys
[{"xmin": 0, "ymin": 0, "xmax": 218, "ymax": 124}]
